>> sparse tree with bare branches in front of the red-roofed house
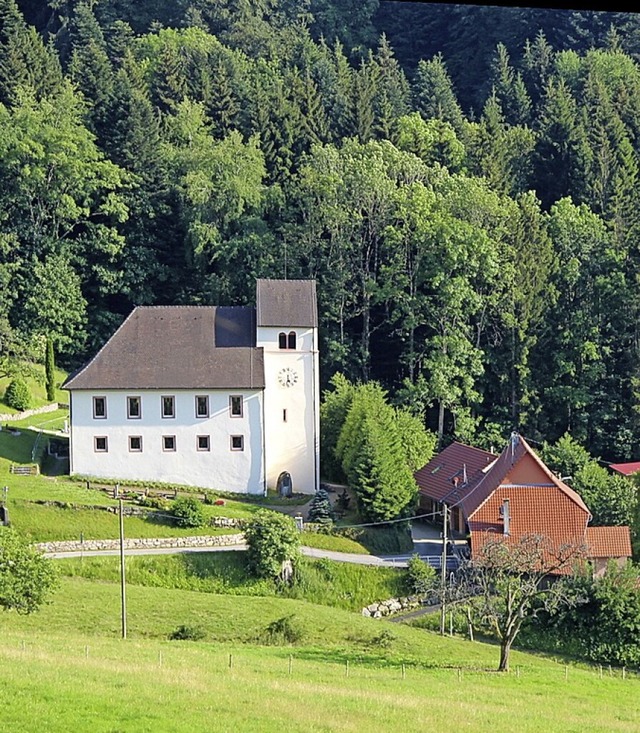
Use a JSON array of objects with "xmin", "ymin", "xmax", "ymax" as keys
[{"xmin": 445, "ymin": 534, "xmax": 585, "ymax": 672}]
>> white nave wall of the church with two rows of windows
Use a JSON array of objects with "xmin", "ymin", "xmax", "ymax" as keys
[{"xmin": 70, "ymin": 390, "xmax": 265, "ymax": 494}]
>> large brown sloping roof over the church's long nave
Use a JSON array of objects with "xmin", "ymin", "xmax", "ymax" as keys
[{"xmin": 62, "ymin": 306, "xmax": 264, "ymax": 390}]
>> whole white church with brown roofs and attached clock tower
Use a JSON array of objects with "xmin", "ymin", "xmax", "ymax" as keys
[{"xmin": 63, "ymin": 280, "xmax": 320, "ymax": 494}]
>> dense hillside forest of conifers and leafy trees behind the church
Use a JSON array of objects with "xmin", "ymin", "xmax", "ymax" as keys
[{"xmin": 0, "ymin": 0, "xmax": 640, "ymax": 461}]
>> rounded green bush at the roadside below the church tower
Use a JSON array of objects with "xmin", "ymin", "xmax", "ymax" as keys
[{"xmin": 245, "ymin": 509, "xmax": 300, "ymax": 579}]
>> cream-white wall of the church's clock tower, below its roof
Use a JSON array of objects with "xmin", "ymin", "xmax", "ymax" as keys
[{"xmin": 256, "ymin": 326, "xmax": 320, "ymax": 493}]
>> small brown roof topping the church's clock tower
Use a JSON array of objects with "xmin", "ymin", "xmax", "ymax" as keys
[{"xmin": 256, "ymin": 280, "xmax": 318, "ymax": 328}]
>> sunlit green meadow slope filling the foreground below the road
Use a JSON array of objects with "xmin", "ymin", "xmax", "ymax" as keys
[{"xmin": 0, "ymin": 578, "xmax": 640, "ymax": 733}]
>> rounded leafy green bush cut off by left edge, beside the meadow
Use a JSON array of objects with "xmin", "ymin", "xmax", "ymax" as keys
[{"xmin": 0, "ymin": 528, "xmax": 58, "ymax": 614}]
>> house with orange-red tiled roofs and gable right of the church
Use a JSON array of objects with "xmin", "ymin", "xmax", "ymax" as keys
[{"xmin": 415, "ymin": 433, "xmax": 631, "ymax": 573}]
